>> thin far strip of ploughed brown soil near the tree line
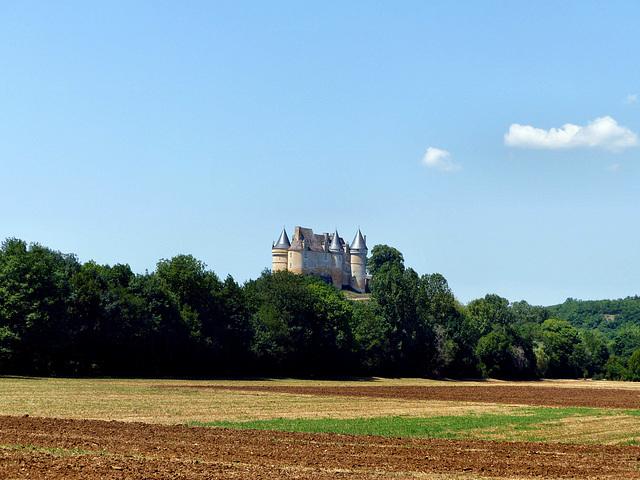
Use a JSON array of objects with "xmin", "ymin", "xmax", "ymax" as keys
[{"xmin": 186, "ymin": 383, "xmax": 640, "ymax": 409}]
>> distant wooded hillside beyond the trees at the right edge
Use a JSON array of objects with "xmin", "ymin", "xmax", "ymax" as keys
[{"xmin": 547, "ymin": 295, "xmax": 640, "ymax": 332}]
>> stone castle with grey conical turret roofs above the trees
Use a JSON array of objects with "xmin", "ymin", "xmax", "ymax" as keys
[{"xmin": 271, "ymin": 227, "xmax": 367, "ymax": 293}]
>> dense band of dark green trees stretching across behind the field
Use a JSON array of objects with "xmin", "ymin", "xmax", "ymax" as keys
[{"xmin": 0, "ymin": 238, "xmax": 640, "ymax": 380}]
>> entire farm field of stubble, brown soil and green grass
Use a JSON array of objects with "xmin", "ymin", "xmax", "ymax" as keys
[{"xmin": 0, "ymin": 377, "xmax": 640, "ymax": 479}]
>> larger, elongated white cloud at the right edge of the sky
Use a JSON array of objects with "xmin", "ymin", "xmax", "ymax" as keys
[{"xmin": 504, "ymin": 116, "xmax": 638, "ymax": 151}]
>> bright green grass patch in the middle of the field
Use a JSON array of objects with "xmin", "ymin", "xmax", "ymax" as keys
[{"xmin": 190, "ymin": 408, "xmax": 611, "ymax": 441}]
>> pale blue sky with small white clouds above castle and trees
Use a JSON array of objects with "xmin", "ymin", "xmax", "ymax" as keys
[{"xmin": 0, "ymin": 1, "xmax": 640, "ymax": 305}]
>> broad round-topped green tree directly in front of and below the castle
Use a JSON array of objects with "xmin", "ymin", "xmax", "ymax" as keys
[{"xmin": 245, "ymin": 271, "xmax": 353, "ymax": 375}]
